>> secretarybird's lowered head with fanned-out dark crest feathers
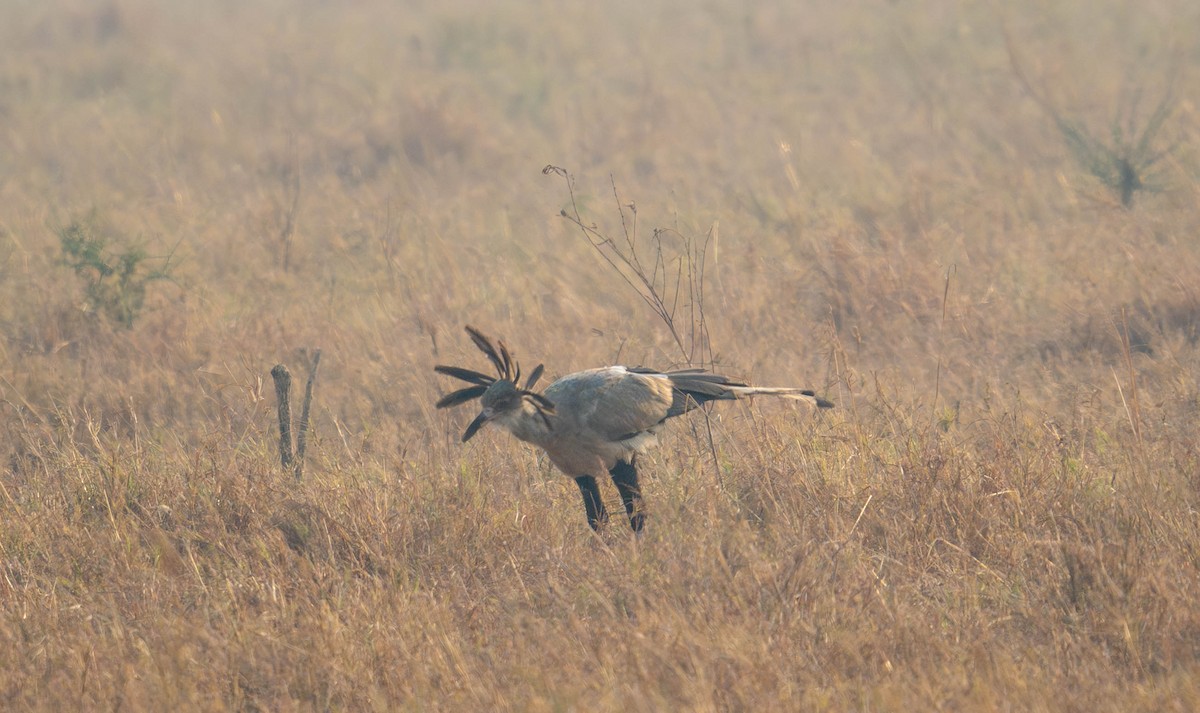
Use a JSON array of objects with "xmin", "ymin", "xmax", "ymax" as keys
[{"xmin": 433, "ymin": 326, "xmax": 554, "ymax": 442}]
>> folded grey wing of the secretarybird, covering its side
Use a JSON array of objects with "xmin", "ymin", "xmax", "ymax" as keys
[{"xmin": 546, "ymin": 366, "xmax": 673, "ymax": 443}]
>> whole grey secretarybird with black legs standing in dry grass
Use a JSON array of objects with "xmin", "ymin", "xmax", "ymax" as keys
[{"xmin": 433, "ymin": 326, "xmax": 833, "ymax": 532}]
